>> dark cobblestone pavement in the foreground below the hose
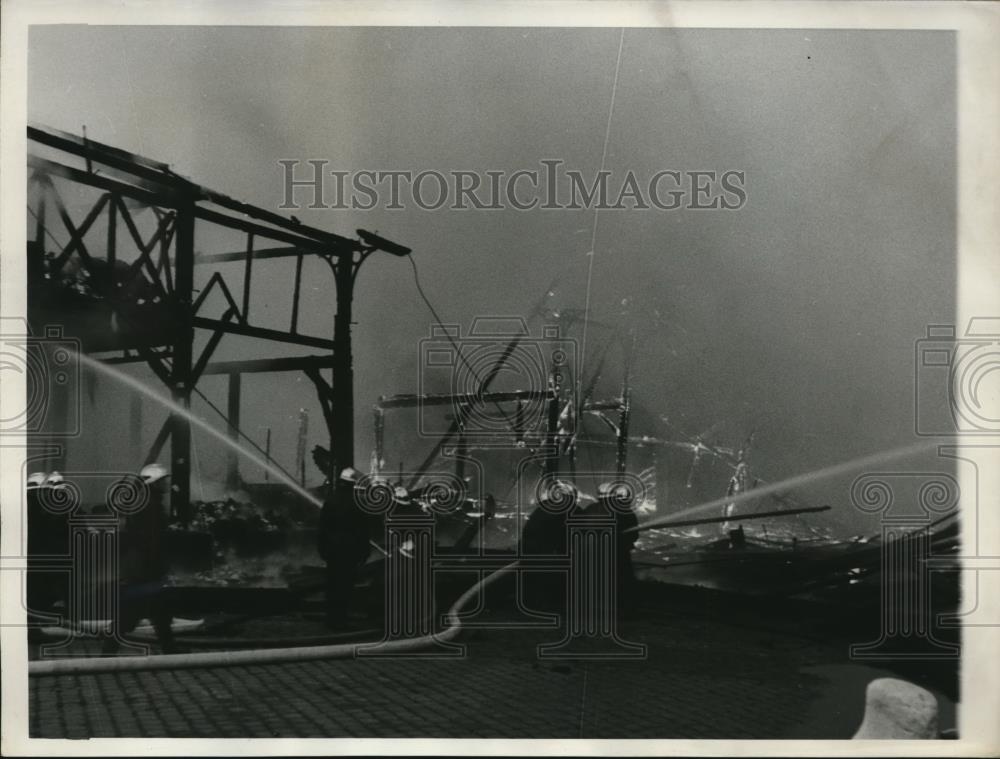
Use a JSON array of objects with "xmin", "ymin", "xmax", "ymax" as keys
[{"xmin": 30, "ymin": 616, "xmax": 880, "ymax": 738}]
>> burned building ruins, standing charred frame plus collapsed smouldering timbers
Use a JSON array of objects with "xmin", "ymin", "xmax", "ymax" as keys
[{"xmin": 28, "ymin": 127, "xmax": 958, "ymax": 664}]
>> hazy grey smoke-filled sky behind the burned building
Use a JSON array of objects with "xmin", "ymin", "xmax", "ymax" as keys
[{"xmin": 28, "ymin": 26, "xmax": 956, "ymax": 522}]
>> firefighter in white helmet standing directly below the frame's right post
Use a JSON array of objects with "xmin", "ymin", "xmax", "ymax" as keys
[{"xmin": 316, "ymin": 467, "xmax": 372, "ymax": 628}]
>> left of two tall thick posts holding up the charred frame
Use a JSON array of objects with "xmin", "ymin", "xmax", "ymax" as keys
[{"xmin": 170, "ymin": 198, "xmax": 194, "ymax": 526}]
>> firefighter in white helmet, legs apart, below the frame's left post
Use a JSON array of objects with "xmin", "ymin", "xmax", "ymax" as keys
[{"xmin": 103, "ymin": 464, "xmax": 176, "ymax": 654}]
